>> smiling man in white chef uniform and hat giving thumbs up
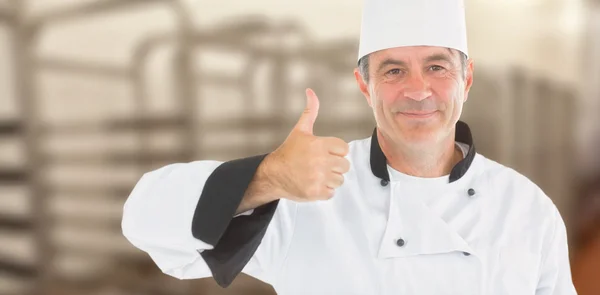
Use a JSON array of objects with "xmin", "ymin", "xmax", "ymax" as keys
[{"xmin": 122, "ymin": 0, "xmax": 576, "ymax": 295}]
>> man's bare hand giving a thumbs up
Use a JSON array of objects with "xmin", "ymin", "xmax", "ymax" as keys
[{"xmin": 270, "ymin": 89, "xmax": 350, "ymax": 201}]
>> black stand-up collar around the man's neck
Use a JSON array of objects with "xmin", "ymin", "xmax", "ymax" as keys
[{"xmin": 371, "ymin": 121, "xmax": 475, "ymax": 182}]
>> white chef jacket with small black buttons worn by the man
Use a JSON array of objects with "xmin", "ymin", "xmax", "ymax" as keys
[{"xmin": 122, "ymin": 121, "xmax": 576, "ymax": 295}]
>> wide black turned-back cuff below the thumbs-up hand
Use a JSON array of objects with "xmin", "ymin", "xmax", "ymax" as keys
[{"xmin": 192, "ymin": 155, "xmax": 279, "ymax": 287}]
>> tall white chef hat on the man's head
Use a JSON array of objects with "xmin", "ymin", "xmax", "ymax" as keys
[{"xmin": 358, "ymin": 0, "xmax": 468, "ymax": 60}]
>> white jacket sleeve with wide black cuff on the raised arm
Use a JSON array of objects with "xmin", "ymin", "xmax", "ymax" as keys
[{"xmin": 121, "ymin": 155, "xmax": 296, "ymax": 287}]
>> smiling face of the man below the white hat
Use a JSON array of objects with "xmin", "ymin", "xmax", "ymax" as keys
[{"xmin": 355, "ymin": 46, "xmax": 473, "ymax": 147}]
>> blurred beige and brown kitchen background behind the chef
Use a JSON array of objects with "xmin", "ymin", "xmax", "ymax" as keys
[{"xmin": 0, "ymin": 0, "xmax": 600, "ymax": 295}]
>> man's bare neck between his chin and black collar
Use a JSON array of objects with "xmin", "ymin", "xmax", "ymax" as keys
[{"xmin": 377, "ymin": 129, "xmax": 463, "ymax": 178}]
